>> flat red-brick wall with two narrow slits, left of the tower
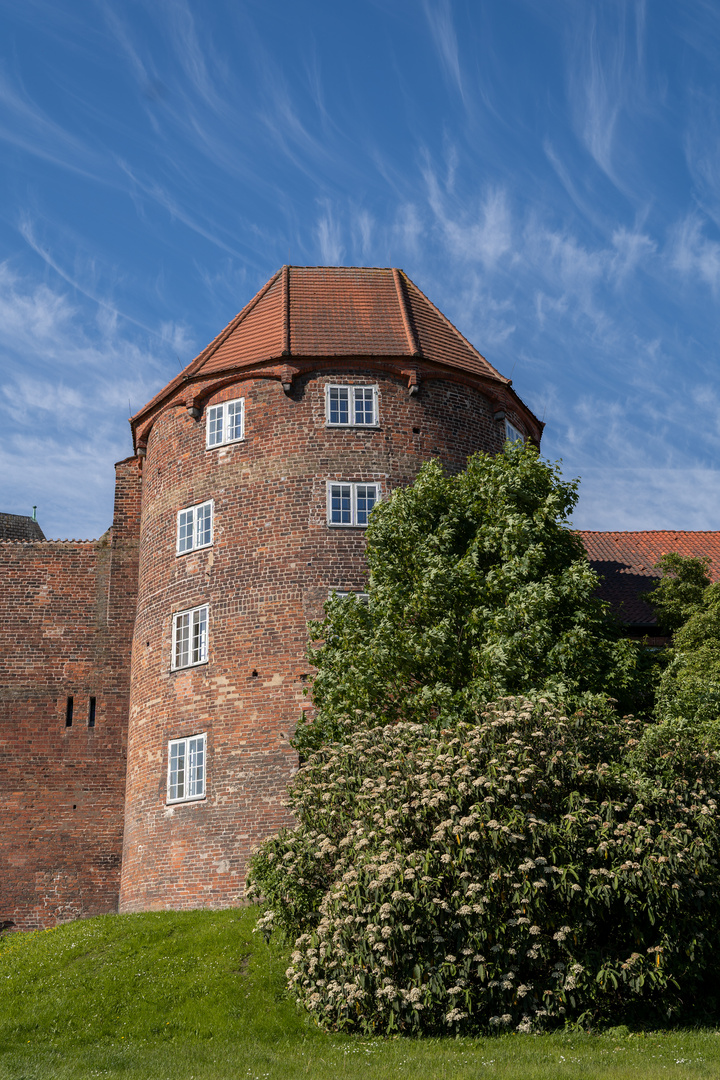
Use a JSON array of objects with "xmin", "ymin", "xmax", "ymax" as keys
[{"xmin": 0, "ymin": 459, "xmax": 140, "ymax": 929}]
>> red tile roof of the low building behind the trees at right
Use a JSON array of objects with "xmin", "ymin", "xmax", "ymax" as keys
[{"xmin": 578, "ymin": 529, "xmax": 720, "ymax": 626}]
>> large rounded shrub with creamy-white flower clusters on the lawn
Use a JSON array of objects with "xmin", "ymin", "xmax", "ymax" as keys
[{"xmin": 248, "ymin": 699, "xmax": 718, "ymax": 1032}]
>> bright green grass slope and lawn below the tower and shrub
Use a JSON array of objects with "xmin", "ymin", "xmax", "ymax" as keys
[{"xmin": 0, "ymin": 909, "xmax": 720, "ymax": 1080}]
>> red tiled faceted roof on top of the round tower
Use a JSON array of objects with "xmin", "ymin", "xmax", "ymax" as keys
[{"xmin": 133, "ymin": 266, "xmax": 524, "ymax": 430}]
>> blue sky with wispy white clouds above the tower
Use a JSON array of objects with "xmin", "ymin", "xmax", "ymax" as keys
[{"xmin": 0, "ymin": 0, "xmax": 720, "ymax": 537}]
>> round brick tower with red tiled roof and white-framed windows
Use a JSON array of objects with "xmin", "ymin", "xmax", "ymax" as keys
[{"xmin": 120, "ymin": 267, "xmax": 542, "ymax": 912}]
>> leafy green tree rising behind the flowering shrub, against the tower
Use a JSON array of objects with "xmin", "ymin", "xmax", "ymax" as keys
[{"xmin": 296, "ymin": 442, "xmax": 641, "ymax": 753}]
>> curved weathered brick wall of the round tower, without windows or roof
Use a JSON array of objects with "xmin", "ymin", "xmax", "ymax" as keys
[{"xmin": 120, "ymin": 360, "xmax": 509, "ymax": 910}]
